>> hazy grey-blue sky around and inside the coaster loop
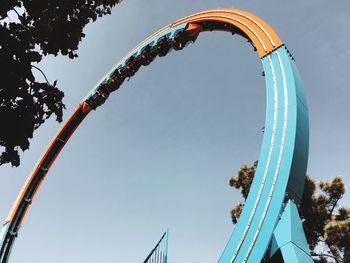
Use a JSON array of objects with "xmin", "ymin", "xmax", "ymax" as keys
[{"xmin": 0, "ymin": 0, "xmax": 350, "ymax": 263}]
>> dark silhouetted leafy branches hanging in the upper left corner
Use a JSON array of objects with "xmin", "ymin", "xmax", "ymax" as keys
[{"xmin": 0, "ymin": 0, "xmax": 121, "ymax": 166}]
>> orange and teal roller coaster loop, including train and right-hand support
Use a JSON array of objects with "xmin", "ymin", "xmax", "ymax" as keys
[{"xmin": 0, "ymin": 8, "xmax": 312, "ymax": 263}]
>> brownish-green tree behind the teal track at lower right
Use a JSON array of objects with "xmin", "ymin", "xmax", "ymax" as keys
[{"xmin": 229, "ymin": 162, "xmax": 350, "ymax": 263}]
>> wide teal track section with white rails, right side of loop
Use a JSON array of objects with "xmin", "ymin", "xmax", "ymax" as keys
[{"xmin": 219, "ymin": 46, "xmax": 308, "ymax": 263}]
